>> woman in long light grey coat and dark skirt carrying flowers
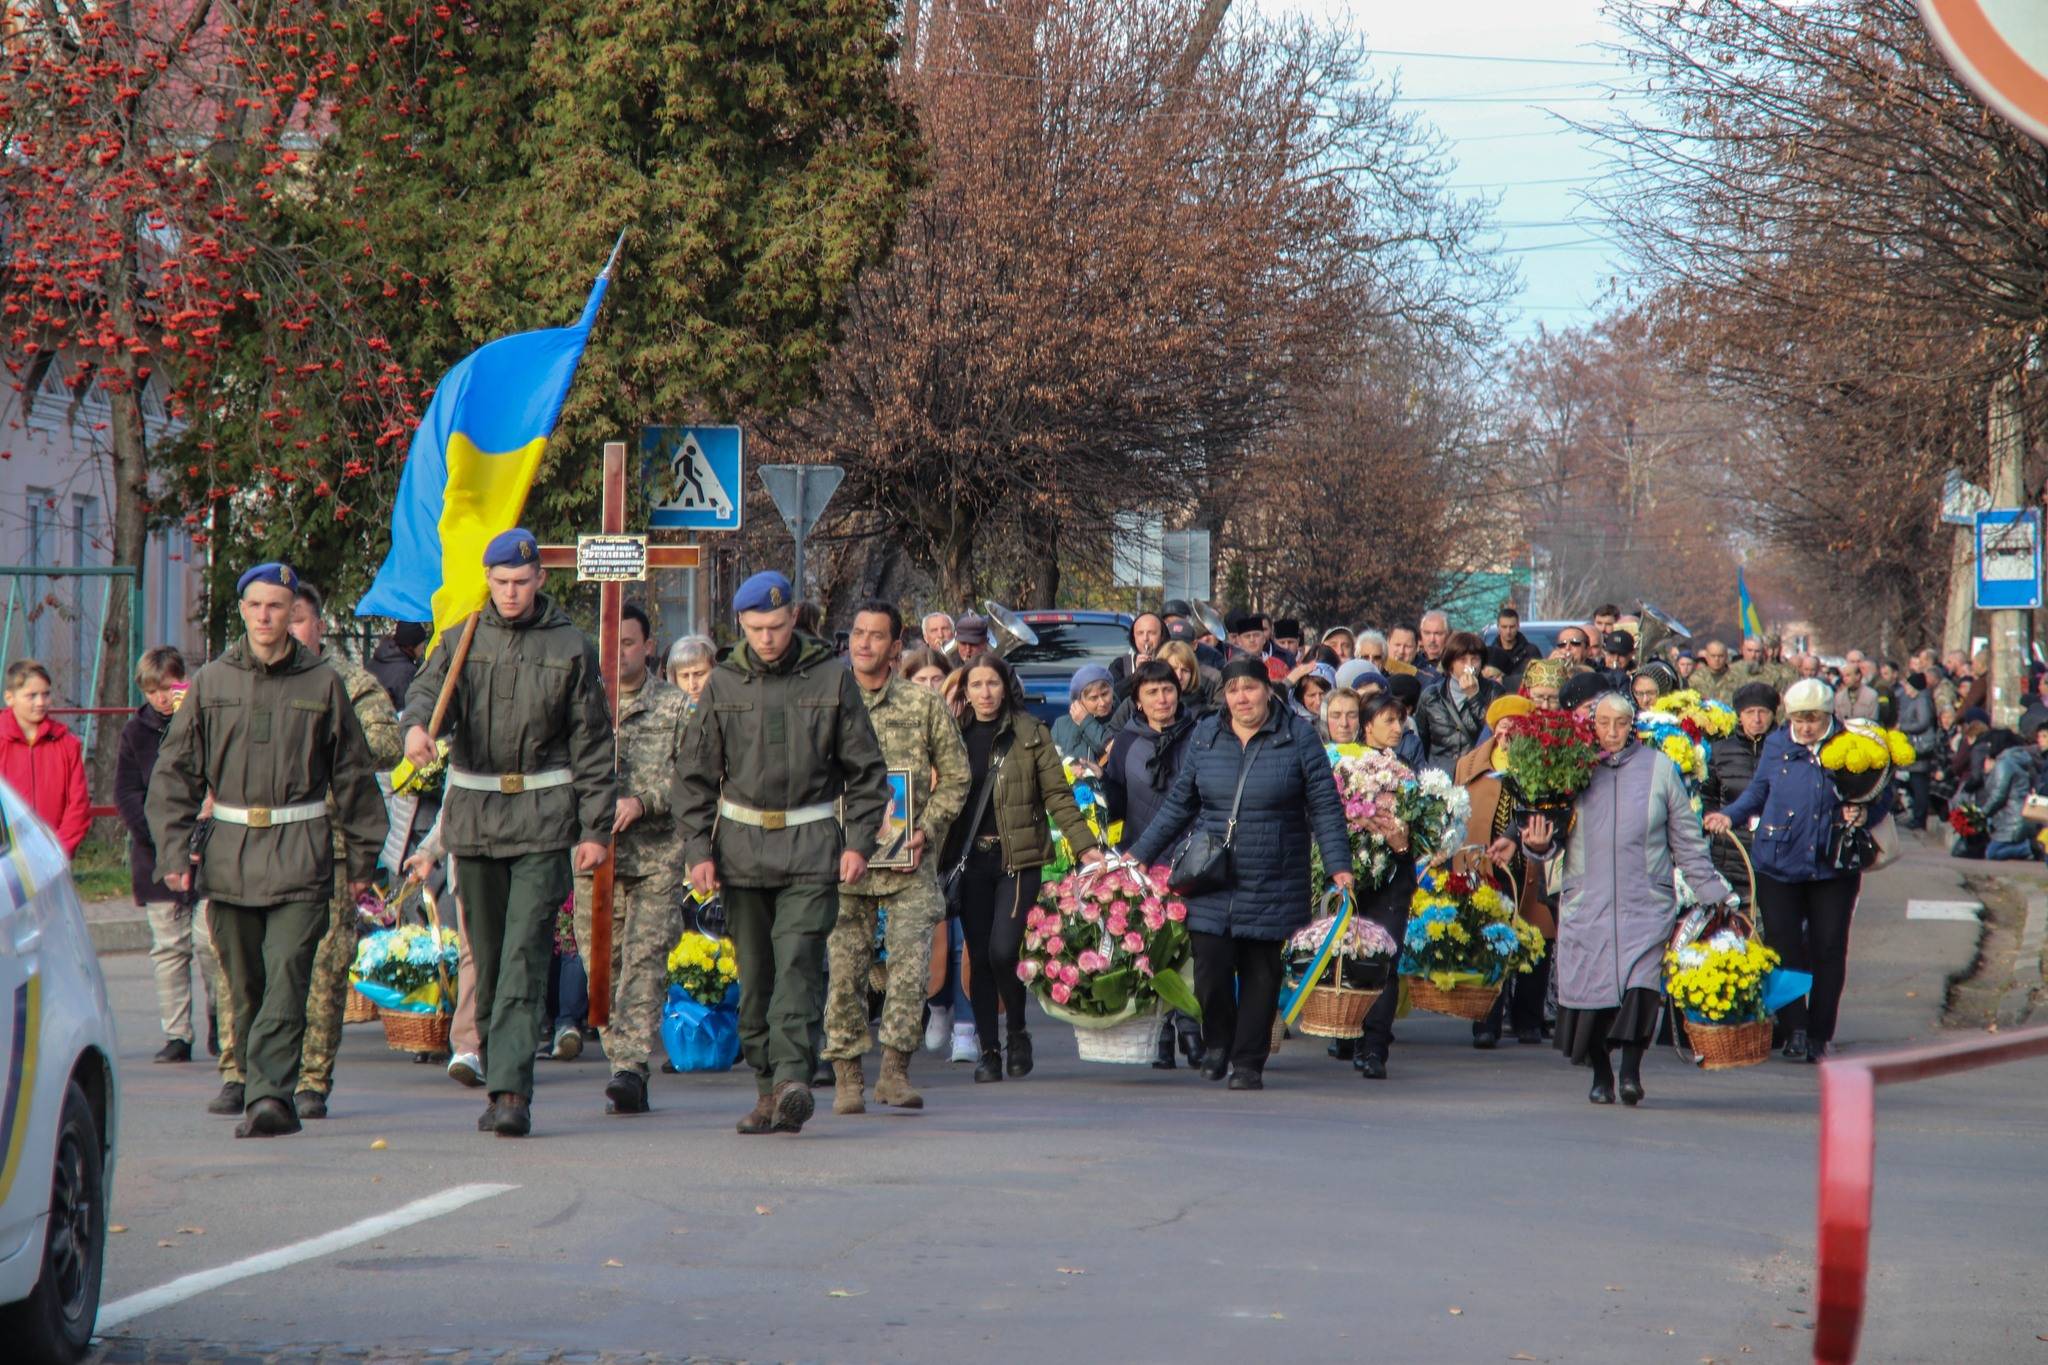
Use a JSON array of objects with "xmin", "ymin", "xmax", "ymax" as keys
[{"xmin": 1522, "ymin": 692, "xmax": 1735, "ymax": 1105}]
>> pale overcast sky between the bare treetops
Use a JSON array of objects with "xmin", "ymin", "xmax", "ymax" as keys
[{"xmin": 1255, "ymin": 0, "xmax": 1626, "ymax": 349}]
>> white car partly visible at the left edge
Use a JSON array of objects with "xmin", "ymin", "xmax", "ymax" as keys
[{"xmin": 0, "ymin": 782, "xmax": 121, "ymax": 1365}]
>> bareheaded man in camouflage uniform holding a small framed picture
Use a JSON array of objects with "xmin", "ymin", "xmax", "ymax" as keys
[{"xmin": 825, "ymin": 602, "xmax": 973, "ymax": 1113}]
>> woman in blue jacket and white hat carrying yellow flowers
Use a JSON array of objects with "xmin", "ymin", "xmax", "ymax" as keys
[{"xmin": 1706, "ymin": 677, "xmax": 1866, "ymax": 1062}]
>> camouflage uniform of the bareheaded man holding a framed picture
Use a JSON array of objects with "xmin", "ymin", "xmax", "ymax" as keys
[{"xmin": 823, "ymin": 677, "xmax": 971, "ymax": 1062}]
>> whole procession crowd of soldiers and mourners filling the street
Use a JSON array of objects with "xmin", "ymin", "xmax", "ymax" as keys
[{"xmin": 79, "ymin": 532, "xmax": 1966, "ymax": 1136}]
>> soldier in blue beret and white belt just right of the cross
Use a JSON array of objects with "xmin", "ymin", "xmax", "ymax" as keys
[{"xmin": 676, "ymin": 573, "xmax": 889, "ymax": 1134}]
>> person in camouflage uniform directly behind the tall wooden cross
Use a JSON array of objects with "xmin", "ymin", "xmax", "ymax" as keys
[{"xmin": 575, "ymin": 604, "xmax": 686, "ymax": 1113}]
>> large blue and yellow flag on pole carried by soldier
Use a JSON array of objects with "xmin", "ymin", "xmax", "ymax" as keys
[{"xmin": 356, "ymin": 237, "xmax": 623, "ymax": 649}]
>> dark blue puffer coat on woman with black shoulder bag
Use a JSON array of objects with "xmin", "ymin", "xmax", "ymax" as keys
[{"xmin": 1130, "ymin": 702, "xmax": 1352, "ymax": 939}]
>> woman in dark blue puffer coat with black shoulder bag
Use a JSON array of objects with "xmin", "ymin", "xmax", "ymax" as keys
[{"xmin": 1130, "ymin": 659, "xmax": 1352, "ymax": 1091}]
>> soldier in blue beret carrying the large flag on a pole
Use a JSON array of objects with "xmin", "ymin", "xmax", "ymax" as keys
[{"xmin": 399, "ymin": 530, "xmax": 616, "ymax": 1138}]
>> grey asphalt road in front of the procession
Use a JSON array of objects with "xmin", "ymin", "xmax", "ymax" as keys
[{"xmin": 83, "ymin": 839, "xmax": 2048, "ymax": 1365}]
